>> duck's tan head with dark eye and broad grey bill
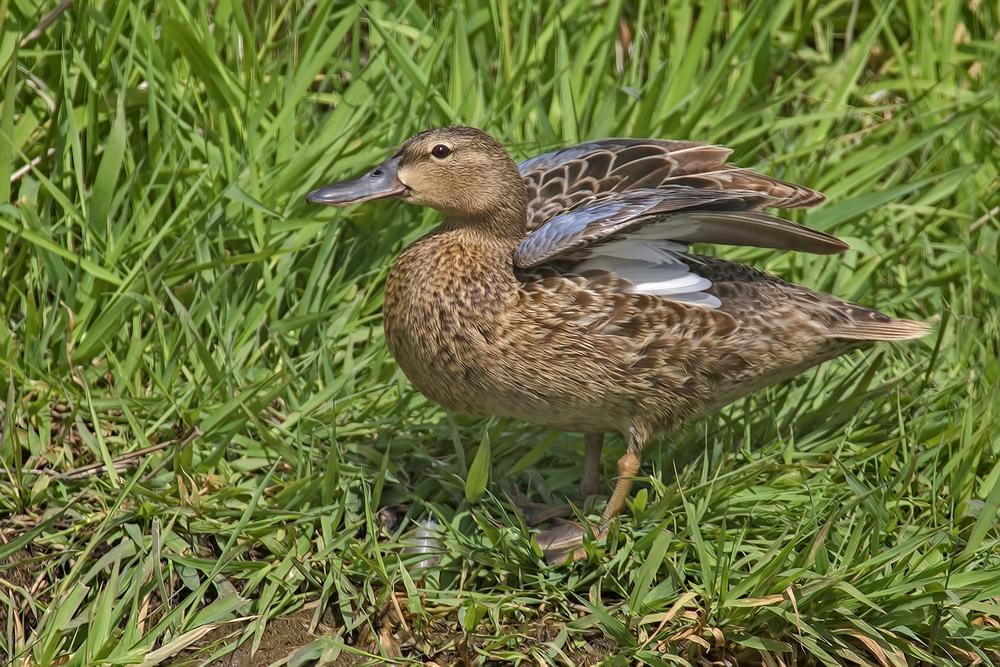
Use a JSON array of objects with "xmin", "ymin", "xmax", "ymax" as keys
[{"xmin": 306, "ymin": 127, "xmax": 527, "ymax": 220}]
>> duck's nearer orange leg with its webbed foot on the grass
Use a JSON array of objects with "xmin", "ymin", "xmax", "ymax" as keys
[{"xmin": 535, "ymin": 426, "xmax": 649, "ymax": 564}]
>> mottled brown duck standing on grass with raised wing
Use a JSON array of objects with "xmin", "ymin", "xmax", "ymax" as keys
[{"xmin": 307, "ymin": 126, "xmax": 931, "ymax": 564}]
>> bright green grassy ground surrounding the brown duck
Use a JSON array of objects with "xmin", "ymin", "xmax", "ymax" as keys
[{"xmin": 0, "ymin": 0, "xmax": 1000, "ymax": 666}]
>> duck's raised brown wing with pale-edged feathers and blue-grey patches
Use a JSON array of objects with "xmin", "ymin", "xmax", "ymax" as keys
[{"xmin": 514, "ymin": 139, "xmax": 848, "ymax": 268}]
